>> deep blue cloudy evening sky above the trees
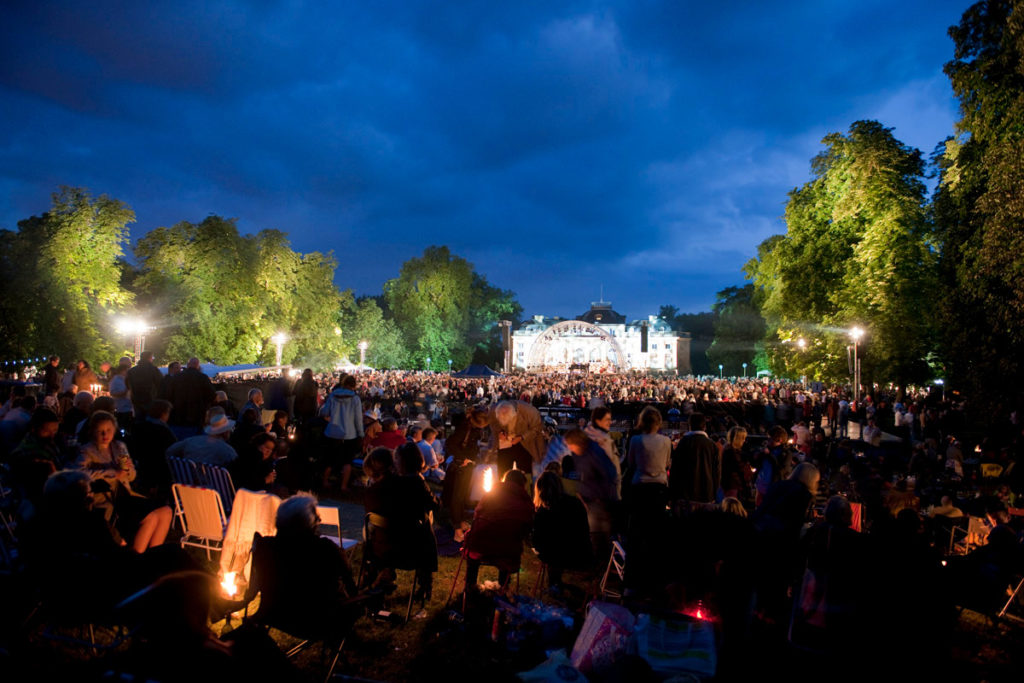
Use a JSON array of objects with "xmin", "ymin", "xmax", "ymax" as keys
[{"xmin": 0, "ymin": 0, "xmax": 970, "ymax": 318}]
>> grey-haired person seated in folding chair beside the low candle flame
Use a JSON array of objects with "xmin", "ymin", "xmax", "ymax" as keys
[{"xmin": 247, "ymin": 494, "xmax": 359, "ymax": 637}]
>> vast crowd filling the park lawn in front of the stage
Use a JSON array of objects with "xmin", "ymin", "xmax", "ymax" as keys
[{"xmin": 0, "ymin": 353, "xmax": 1024, "ymax": 679}]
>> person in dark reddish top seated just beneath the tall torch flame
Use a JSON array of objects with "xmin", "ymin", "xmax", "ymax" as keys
[{"xmin": 465, "ymin": 469, "xmax": 534, "ymax": 590}]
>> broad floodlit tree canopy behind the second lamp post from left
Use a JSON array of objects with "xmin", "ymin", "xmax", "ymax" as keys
[{"xmin": 135, "ymin": 216, "xmax": 351, "ymax": 367}]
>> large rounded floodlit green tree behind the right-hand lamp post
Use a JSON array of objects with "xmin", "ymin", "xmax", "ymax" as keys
[{"xmin": 745, "ymin": 121, "xmax": 936, "ymax": 382}]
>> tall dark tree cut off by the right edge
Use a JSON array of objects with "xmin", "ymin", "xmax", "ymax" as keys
[{"xmin": 934, "ymin": 0, "xmax": 1024, "ymax": 407}]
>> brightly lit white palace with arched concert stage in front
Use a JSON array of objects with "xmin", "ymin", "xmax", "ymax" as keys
[{"xmin": 512, "ymin": 301, "xmax": 690, "ymax": 375}]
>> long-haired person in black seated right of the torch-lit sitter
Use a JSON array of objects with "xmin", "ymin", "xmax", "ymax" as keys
[{"xmin": 532, "ymin": 471, "xmax": 594, "ymax": 589}]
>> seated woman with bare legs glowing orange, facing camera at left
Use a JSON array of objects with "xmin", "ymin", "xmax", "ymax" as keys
[{"xmin": 76, "ymin": 411, "xmax": 172, "ymax": 553}]
